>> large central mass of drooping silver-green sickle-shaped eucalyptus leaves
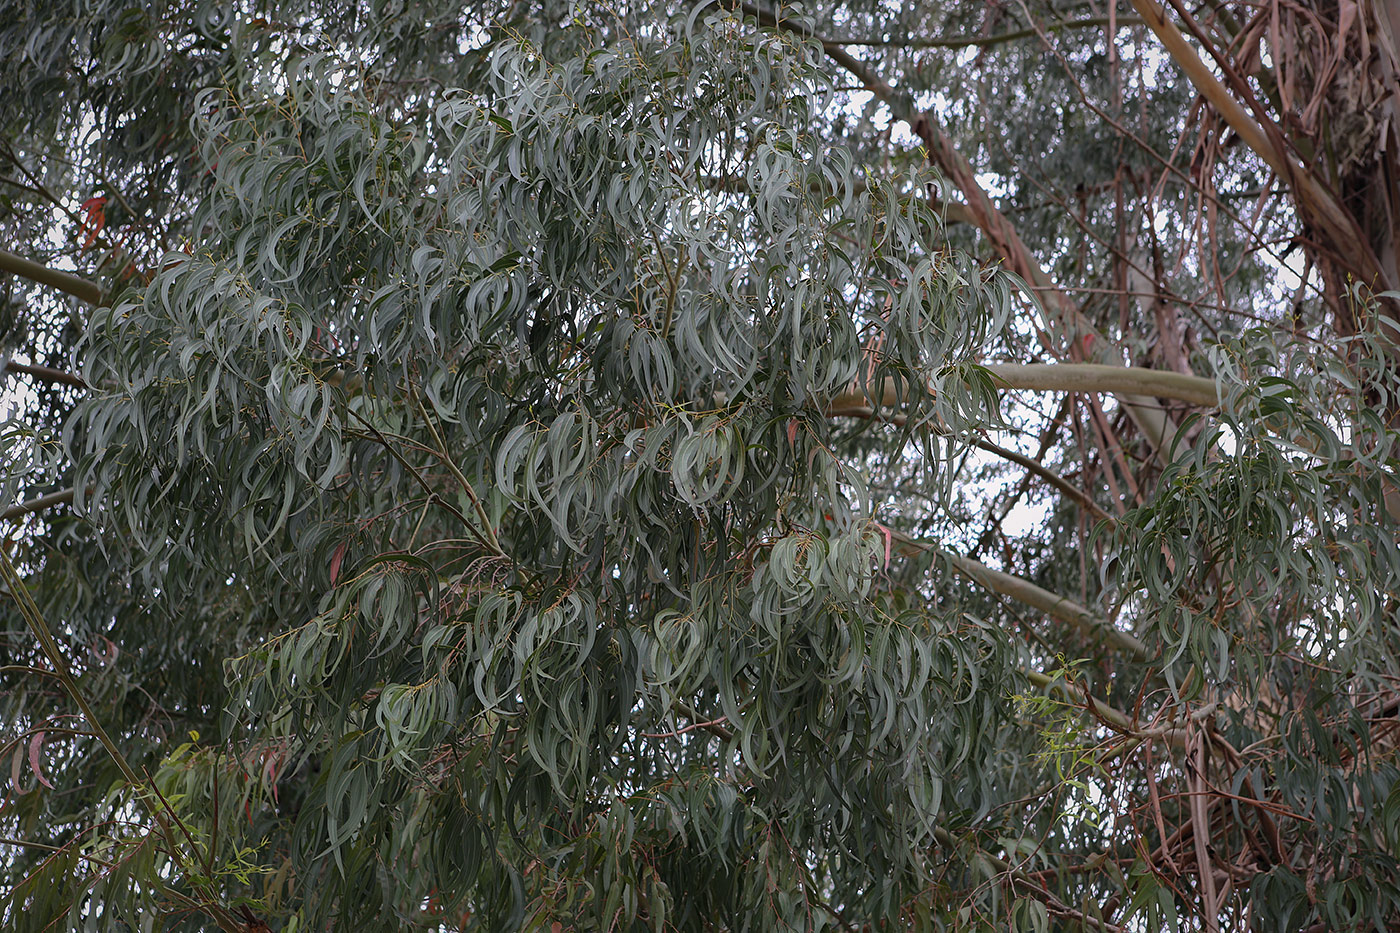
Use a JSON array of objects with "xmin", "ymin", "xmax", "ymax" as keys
[{"xmin": 19, "ymin": 15, "xmax": 1014, "ymax": 929}]
